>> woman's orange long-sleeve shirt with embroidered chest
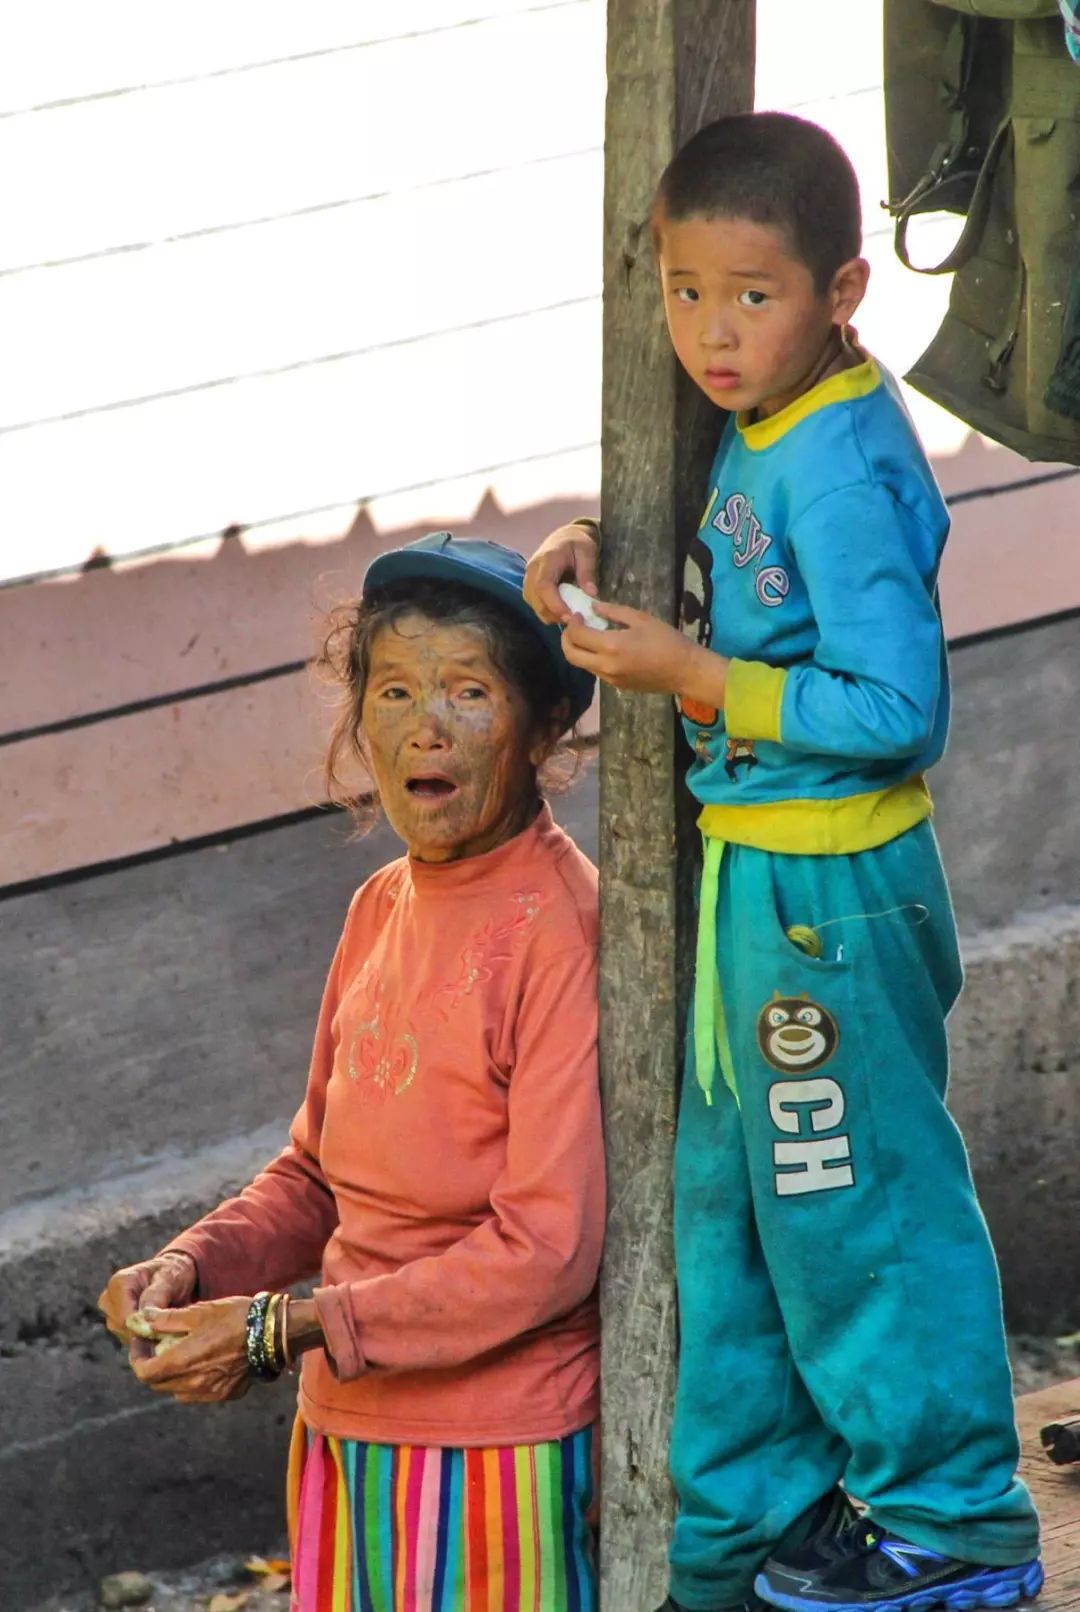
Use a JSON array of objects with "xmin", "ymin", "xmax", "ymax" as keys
[{"xmin": 171, "ymin": 808, "xmax": 604, "ymax": 1444}]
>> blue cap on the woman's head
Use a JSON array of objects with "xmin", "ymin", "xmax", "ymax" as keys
[{"xmin": 364, "ymin": 532, "xmax": 596, "ymax": 727}]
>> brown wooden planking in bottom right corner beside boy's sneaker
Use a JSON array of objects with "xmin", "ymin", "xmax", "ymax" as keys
[{"xmin": 1017, "ymin": 1377, "xmax": 1080, "ymax": 1612}]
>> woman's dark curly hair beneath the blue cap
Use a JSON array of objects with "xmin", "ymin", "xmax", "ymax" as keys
[{"xmin": 314, "ymin": 582, "xmax": 579, "ymax": 829}]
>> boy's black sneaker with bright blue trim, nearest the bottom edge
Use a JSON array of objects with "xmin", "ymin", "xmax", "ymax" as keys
[{"xmin": 754, "ymin": 1519, "xmax": 1043, "ymax": 1612}]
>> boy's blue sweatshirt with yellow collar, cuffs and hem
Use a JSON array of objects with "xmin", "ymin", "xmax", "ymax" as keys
[{"xmin": 682, "ymin": 359, "xmax": 949, "ymax": 853}]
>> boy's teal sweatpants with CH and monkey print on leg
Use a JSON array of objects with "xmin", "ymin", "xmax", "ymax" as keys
[{"xmin": 671, "ymin": 822, "xmax": 1038, "ymax": 1609}]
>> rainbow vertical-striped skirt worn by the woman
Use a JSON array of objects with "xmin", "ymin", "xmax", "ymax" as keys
[{"xmin": 289, "ymin": 1417, "xmax": 596, "ymax": 1612}]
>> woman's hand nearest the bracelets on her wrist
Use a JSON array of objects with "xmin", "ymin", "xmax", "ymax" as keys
[{"xmin": 132, "ymin": 1298, "xmax": 253, "ymax": 1404}]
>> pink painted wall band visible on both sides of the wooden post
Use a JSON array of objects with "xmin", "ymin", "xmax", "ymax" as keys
[{"xmin": 0, "ymin": 438, "xmax": 1080, "ymax": 885}]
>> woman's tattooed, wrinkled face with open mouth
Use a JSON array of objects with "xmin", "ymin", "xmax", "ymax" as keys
[{"xmin": 361, "ymin": 611, "xmax": 550, "ymax": 862}]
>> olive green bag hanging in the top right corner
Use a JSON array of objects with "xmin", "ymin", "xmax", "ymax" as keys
[{"xmin": 885, "ymin": 0, "xmax": 1080, "ymax": 464}]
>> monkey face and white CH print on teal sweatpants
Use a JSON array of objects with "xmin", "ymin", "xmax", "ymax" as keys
[{"xmin": 758, "ymin": 991, "xmax": 854, "ymax": 1198}]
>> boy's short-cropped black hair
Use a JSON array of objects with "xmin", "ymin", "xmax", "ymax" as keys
[{"xmin": 653, "ymin": 111, "xmax": 862, "ymax": 292}]
